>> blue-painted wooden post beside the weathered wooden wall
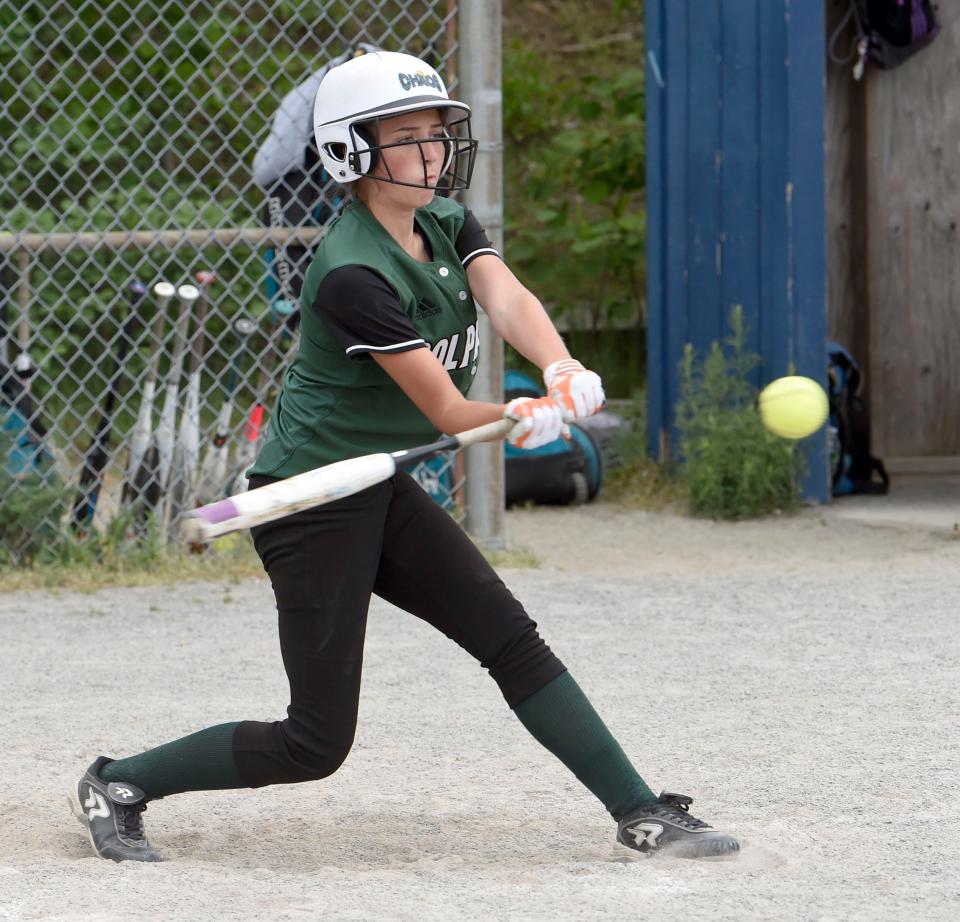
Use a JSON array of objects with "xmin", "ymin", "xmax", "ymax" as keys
[{"xmin": 646, "ymin": 0, "xmax": 829, "ymax": 501}]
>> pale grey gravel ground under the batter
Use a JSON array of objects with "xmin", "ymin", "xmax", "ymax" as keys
[{"xmin": 0, "ymin": 505, "xmax": 960, "ymax": 922}]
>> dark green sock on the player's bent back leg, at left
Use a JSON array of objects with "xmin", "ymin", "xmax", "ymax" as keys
[{"xmin": 100, "ymin": 723, "xmax": 249, "ymax": 799}]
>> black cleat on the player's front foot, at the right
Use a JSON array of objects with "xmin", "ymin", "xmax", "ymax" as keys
[{"xmin": 617, "ymin": 792, "xmax": 740, "ymax": 858}]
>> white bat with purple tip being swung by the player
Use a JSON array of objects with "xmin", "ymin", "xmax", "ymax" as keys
[{"xmin": 180, "ymin": 419, "xmax": 515, "ymax": 544}]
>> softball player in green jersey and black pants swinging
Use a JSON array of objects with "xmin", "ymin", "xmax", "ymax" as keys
[{"xmin": 78, "ymin": 52, "xmax": 739, "ymax": 861}]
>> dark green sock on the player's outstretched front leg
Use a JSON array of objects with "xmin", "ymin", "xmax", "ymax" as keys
[{"xmin": 514, "ymin": 672, "xmax": 657, "ymax": 819}]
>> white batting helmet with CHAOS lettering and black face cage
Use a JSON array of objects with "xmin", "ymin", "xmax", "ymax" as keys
[{"xmin": 313, "ymin": 51, "xmax": 477, "ymax": 189}]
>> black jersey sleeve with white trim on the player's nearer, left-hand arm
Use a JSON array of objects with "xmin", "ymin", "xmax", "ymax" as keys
[{"xmin": 313, "ymin": 266, "xmax": 427, "ymax": 358}]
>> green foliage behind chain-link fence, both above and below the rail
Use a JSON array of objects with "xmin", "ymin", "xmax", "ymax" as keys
[{"xmin": 0, "ymin": 0, "xmax": 458, "ymax": 451}]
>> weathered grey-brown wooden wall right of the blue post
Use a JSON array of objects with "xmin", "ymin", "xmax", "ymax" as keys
[{"xmin": 825, "ymin": 0, "xmax": 960, "ymax": 474}]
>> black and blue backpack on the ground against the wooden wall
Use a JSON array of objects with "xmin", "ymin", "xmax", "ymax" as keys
[{"xmin": 827, "ymin": 341, "xmax": 890, "ymax": 496}]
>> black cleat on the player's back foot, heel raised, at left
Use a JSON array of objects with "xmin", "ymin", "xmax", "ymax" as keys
[{"xmin": 77, "ymin": 756, "xmax": 160, "ymax": 861}]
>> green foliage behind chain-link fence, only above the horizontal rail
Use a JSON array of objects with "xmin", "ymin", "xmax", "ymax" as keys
[{"xmin": 0, "ymin": 0, "xmax": 443, "ymax": 221}]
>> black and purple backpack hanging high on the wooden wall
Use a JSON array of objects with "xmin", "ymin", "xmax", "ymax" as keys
[{"xmin": 851, "ymin": 0, "xmax": 940, "ymax": 78}]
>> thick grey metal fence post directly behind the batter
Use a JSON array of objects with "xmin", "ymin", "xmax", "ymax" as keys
[{"xmin": 459, "ymin": 0, "xmax": 506, "ymax": 549}]
